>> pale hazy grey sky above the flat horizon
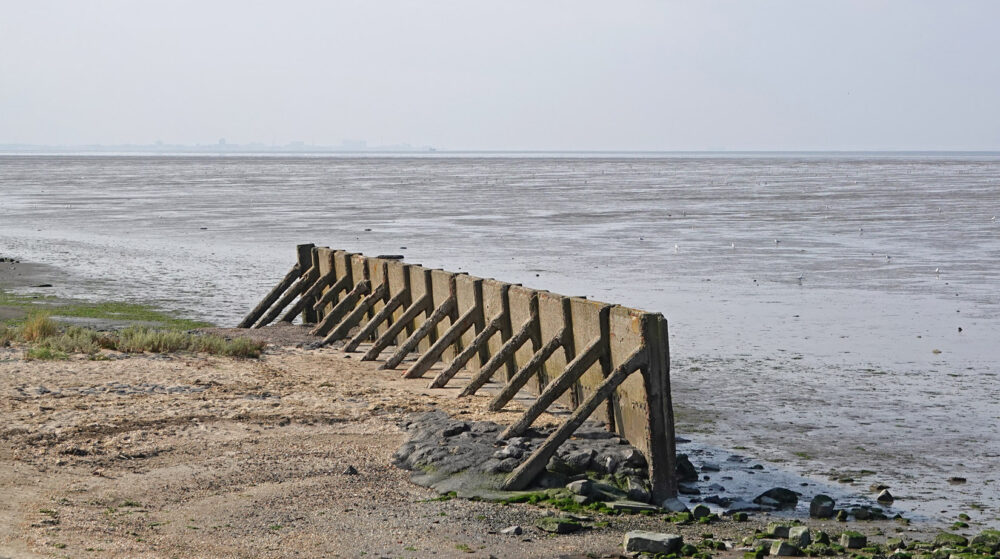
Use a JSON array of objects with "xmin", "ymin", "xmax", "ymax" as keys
[{"xmin": 0, "ymin": 0, "xmax": 1000, "ymax": 150}]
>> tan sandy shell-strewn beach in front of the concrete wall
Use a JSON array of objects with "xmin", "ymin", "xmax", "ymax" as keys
[{"xmin": 0, "ymin": 262, "xmax": 968, "ymax": 557}]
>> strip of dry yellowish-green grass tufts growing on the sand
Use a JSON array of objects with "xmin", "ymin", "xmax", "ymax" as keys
[{"xmin": 0, "ymin": 312, "xmax": 264, "ymax": 360}]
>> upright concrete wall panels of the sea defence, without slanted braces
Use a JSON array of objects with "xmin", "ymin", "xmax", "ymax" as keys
[{"xmin": 278, "ymin": 247, "xmax": 674, "ymax": 493}]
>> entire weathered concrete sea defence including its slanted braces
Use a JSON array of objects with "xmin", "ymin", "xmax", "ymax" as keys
[{"xmin": 239, "ymin": 244, "xmax": 677, "ymax": 503}]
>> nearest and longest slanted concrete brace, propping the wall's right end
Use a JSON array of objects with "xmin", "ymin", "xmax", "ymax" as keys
[{"xmin": 501, "ymin": 347, "xmax": 649, "ymax": 491}]
